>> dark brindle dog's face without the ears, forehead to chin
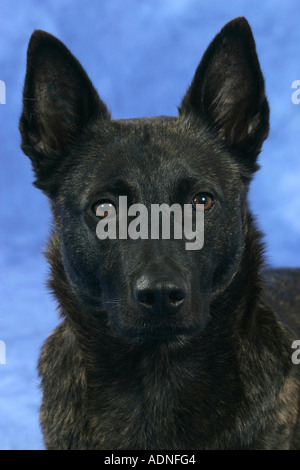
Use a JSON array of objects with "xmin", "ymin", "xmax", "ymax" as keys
[{"xmin": 55, "ymin": 118, "xmax": 245, "ymax": 336}]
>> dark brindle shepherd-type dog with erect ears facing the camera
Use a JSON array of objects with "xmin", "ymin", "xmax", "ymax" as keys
[{"xmin": 20, "ymin": 17, "xmax": 300, "ymax": 450}]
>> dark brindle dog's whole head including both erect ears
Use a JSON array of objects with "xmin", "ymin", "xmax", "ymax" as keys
[{"xmin": 20, "ymin": 19, "xmax": 269, "ymax": 338}]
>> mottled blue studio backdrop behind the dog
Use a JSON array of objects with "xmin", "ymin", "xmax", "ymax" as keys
[{"xmin": 0, "ymin": 0, "xmax": 300, "ymax": 449}]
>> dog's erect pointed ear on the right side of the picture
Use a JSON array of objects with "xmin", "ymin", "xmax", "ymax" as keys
[{"xmin": 179, "ymin": 18, "xmax": 269, "ymax": 170}]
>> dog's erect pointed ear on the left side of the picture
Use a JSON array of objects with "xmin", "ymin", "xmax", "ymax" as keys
[{"xmin": 20, "ymin": 31, "xmax": 110, "ymax": 189}]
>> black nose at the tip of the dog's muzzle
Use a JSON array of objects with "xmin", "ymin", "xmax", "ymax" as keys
[{"xmin": 133, "ymin": 274, "xmax": 187, "ymax": 315}]
